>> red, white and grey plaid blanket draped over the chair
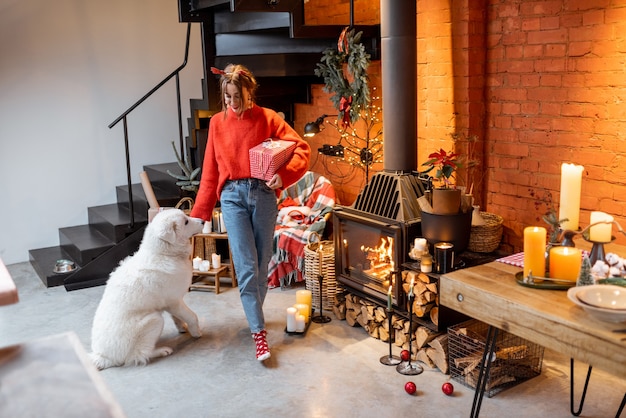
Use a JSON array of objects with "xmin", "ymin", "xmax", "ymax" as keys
[{"xmin": 268, "ymin": 171, "xmax": 335, "ymax": 288}]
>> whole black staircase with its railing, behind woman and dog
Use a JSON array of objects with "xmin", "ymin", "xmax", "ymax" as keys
[{"xmin": 29, "ymin": 0, "xmax": 380, "ymax": 290}]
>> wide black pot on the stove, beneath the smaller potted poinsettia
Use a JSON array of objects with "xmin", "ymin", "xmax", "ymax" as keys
[{"xmin": 422, "ymin": 211, "xmax": 472, "ymax": 254}]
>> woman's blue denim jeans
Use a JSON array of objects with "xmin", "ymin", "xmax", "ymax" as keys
[{"xmin": 220, "ymin": 179, "xmax": 278, "ymax": 333}]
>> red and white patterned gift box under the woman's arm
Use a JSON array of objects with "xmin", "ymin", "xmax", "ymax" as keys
[{"xmin": 250, "ymin": 139, "xmax": 296, "ymax": 180}]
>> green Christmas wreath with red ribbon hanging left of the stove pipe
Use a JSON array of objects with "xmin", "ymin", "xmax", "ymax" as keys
[{"xmin": 315, "ymin": 27, "xmax": 370, "ymax": 128}]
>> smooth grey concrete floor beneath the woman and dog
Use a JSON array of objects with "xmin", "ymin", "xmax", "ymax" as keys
[{"xmin": 0, "ymin": 263, "xmax": 626, "ymax": 418}]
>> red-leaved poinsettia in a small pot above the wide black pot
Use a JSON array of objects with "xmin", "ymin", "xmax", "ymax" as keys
[{"xmin": 422, "ymin": 148, "xmax": 462, "ymax": 215}]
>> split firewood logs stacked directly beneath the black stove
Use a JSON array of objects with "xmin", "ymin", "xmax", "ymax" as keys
[{"xmin": 333, "ymin": 290, "xmax": 448, "ymax": 374}]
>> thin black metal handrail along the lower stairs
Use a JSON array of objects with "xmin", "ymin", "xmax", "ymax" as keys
[{"xmin": 109, "ymin": 23, "xmax": 191, "ymax": 228}]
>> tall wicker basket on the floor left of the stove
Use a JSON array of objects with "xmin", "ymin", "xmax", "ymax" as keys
[{"xmin": 304, "ymin": 233, "xmax": 343, "ymax": 311}]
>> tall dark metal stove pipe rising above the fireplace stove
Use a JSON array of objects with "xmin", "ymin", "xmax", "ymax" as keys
[{"xmin": 380, "ymin": 0, "xmax": 417, "ymax": 173}]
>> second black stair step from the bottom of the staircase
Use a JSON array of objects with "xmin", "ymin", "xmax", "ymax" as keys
[{"xmin": 59, "ymin": 225, "xmax": 115, "ymax": 266}]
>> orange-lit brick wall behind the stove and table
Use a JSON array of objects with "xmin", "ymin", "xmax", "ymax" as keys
[{"xmin": 296, "ymin": 0, "xmax": 626, "ymax": 251}]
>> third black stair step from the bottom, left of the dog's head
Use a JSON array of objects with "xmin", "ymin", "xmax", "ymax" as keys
[{"xmin": 87, "ymin": 203, "xmax": 148, "ymax": 243}]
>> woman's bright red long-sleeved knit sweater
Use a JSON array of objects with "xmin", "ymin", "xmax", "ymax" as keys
[{"xmin": 191, "ymin": 106, "xmax": 311, "ymax": 220}]
